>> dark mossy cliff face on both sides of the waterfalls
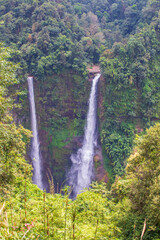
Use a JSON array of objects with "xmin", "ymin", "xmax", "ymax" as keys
[{"xmin": 17, "ymin": 64, "xmax": 156, "ymax": 188}]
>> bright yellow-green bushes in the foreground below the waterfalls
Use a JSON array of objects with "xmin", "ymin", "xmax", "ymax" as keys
[{"xmin": 0, "ymin": 181, "xmax": 119, "ymax": 240}]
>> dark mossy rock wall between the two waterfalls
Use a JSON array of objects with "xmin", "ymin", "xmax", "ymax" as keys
[{"xmin": 17, "ymin": 71, "xmax": 91, "ymax": 191}]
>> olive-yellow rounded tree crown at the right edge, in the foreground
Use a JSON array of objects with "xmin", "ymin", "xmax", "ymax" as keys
[{"xmin": 126, "ymin": 124, "xmax": 160, "ymax": 217}]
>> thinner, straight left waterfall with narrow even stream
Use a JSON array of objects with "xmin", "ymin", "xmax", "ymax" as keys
[{"xmin": 27, "ymin": 77, "xmax": 43, "ymax": 189}]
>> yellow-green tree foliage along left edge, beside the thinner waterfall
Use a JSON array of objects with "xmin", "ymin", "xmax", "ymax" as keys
[{"xmin": 0, "ymin": 47, "xmax": 31, "ymax": 190}]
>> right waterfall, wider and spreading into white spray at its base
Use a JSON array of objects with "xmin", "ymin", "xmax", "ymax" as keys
[{"xmin": 68, "ymin": 74, "xmax": 100, "ymax": 198}]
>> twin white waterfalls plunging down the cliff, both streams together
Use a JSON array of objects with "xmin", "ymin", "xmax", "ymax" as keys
[{"xmin": 27, "ymin": 74, "xmax": 100, "ymax": 193}]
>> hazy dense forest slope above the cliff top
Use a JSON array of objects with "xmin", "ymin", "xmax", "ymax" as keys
[{"xmin": 0, "ymin": 0, "xmax": 159, "ymax": 78}]
